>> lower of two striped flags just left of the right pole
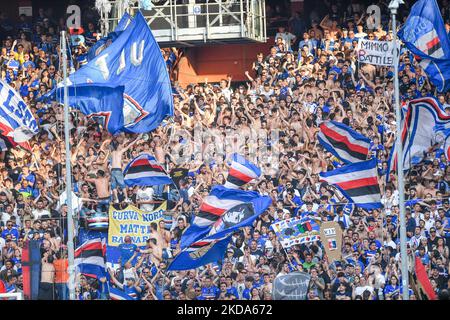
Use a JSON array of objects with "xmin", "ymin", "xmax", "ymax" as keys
[{"xmin": 320, "ymin": 158, "xmax": 381, "ymax": 210}]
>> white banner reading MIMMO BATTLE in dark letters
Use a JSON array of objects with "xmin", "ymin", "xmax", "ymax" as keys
[{"xmin": 356, "ymin": 39, "xmax": 398, "ymax": 66}]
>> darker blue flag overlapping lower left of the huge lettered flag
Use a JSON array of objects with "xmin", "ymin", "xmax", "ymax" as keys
[{"xmin": 56, "ymin": 84, "xmax": 125, "ymax": 134}]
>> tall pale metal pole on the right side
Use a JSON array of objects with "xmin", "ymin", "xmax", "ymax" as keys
[{"xmin": 389, "ymin": 0, "xmax": 409, "ymax": 300}]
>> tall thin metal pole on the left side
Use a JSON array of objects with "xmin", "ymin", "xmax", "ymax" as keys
[{"xmin": 61, "ymin": 31, "xmax": 75, "ymax": 300}]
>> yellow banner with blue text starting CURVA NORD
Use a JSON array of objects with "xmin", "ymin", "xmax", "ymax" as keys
[{"xmin": 108, "ymin": 202, "xmax": 167, "ymax": 247}]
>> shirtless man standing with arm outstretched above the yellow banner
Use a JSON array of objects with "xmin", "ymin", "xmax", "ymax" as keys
[{"xmin": 111, "ymin": 137, "xmax": 143, "ymax": 203}]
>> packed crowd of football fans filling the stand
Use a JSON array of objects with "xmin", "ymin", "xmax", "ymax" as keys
[{"xmin": 0, "ymin": 1, "xmax": 450, "ymax": 300}]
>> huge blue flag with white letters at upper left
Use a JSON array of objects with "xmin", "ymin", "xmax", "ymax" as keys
[{"xmin": 52, "ymin": 12, "xmax": 173, "ymax": 134}]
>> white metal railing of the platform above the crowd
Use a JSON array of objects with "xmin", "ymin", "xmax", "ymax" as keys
[{"xmin": 103, "ymin": 0, "xmax": 267, "ymax": 43}]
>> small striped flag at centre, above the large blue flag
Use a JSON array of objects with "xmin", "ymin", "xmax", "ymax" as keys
[{"xmin": 224, "ymin": 153, "xmax": 261, "ymax": 189}]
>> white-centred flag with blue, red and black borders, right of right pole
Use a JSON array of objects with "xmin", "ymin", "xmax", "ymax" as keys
[{"xmin": 387, "ymin": 97, "xmax": 450, "ymax": 181}]
